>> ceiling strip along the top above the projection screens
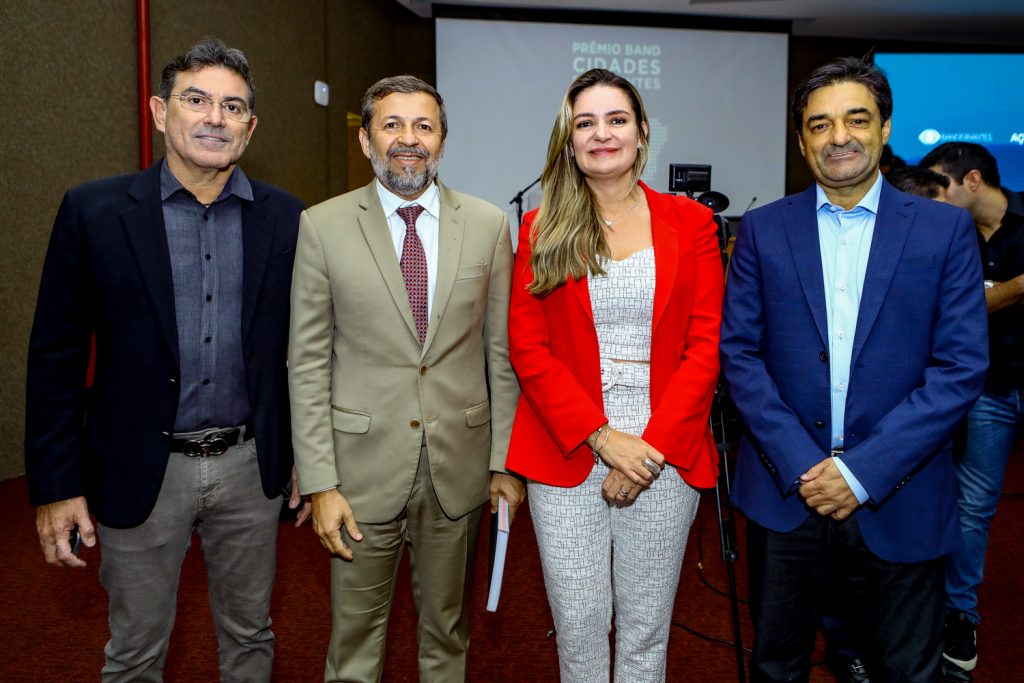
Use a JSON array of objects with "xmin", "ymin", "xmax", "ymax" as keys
[{"xmin": 397, "ymin": 0, "xmax": 1024, "ymax": 49}]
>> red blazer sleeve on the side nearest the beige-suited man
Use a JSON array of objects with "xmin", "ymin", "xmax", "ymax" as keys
[{"xmin": 509, "ymin": 218, "xmax": 608, "ymax": 458}]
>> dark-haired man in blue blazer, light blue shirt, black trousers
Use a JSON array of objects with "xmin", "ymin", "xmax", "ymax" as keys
[{"xmin": 721, "ymin": 58, "xmax": 987, "ymax": 682}]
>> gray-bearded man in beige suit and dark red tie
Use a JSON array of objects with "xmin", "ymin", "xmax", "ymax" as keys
[{"xmin": 289, "ymin": 76, "xmax": 524, "ymax": 682}]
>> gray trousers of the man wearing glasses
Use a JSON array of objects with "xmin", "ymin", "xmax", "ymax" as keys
[{"xmin": 99, "ymin": 439, "xmax": 282, "ymax": 683}]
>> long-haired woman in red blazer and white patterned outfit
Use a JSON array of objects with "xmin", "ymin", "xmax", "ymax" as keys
[{"xmin": 507, "ymin": 70, "xmax": 723, "ymax": 683}]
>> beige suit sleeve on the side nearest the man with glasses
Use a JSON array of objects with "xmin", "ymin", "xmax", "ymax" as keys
[{"xmin": 288, "ymin": 211, "xmax": 340, "ymax": 494}]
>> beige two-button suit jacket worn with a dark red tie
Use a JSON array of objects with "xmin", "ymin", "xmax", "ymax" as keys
[{"xmin": 288, "ymin": 182, "xmax": 519, "ymax": 523}]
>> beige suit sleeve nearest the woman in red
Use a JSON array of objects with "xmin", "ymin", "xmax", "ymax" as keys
[{"xmin": 483, "ymin": 212, "xmax": 519, "ymax": 472}]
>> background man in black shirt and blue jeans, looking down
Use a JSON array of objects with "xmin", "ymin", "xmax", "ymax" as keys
[{"xmin": 921, "ymin": 142, "xmax": 1024, "ymax": 672}]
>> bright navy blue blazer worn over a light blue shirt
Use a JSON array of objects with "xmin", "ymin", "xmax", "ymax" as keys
[{"xmin": 721, "ymin": 182, "xmax": 988, "ymax": 562}]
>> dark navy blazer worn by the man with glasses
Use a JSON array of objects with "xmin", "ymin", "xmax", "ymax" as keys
[{"xmin": 25, "ymin": 163, "xmax": 302, "ymax": 527}]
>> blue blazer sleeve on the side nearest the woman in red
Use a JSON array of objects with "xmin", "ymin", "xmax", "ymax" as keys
[{"xmin": 721, "ymin": 211, "xmax": 826, "ymax": 495}]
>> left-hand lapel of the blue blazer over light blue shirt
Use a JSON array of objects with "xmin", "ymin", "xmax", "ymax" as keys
[{"xmin": 783, "ymin": 185, "xmax": 828, "ymax": 348}]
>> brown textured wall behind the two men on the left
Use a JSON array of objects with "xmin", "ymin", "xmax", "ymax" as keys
[{"xmin": 0, "ymin": 0, "xmax": 434, "ymax": 479}]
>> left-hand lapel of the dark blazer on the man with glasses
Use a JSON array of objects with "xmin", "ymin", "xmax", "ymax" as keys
[{"xmin": 121, "ymin": 162, "xmax": 179, "ymax": 365}]
